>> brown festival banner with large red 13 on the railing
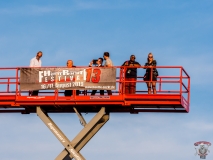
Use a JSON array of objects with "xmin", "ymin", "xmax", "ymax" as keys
[{"xmin": 20, "ymin": 67, "xmax": 116, "ymax": 90}]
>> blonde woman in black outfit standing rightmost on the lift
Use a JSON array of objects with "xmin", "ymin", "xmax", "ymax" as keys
[{"xmin": 144, "ymin": 53, "xmax": 158, "ymax": 94}]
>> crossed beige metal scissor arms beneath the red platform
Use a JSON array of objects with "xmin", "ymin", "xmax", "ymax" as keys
[{"xmin": 37, "ymin": 107, "xmax": 109, "ymax": 160}]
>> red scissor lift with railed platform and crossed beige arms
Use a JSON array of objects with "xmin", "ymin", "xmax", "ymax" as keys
[{"xmin": 0, "ymin": 66, "xmax": 190, "ymax": 160}]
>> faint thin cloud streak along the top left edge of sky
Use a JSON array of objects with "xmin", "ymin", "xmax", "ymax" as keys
[{"xmin": 0, "ymin": 0, "xmax": 150, "ymax": 16}]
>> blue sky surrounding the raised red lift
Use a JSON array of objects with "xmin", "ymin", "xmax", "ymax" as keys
[{"xmin": 0, "ymin": 0, "xmax": 213, "ymax": 160}]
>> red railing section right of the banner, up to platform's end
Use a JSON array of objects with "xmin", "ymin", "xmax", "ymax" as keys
[{"xmin": 120, "ymin": 66, "xmax": 190, "ymax": 101}]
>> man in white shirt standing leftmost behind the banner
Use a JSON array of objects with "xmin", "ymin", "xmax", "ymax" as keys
[{"xmin": 29, "ymin": 51, "xmax": 43, "ymax": 96}]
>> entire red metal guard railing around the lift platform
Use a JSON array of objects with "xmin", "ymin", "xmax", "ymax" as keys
[{"xmin": 0, "ymin": 66, "xmax": 190, "ymax": 102}]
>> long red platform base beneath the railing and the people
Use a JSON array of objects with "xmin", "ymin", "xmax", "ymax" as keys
[{"xmin": 0, "ymin": 94, "xmax": 189, "ymax": 114}]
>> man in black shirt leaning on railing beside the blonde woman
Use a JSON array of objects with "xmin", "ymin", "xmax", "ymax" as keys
[{"xmin": 122, "ymin": 55, "xmax": 141, "ymax": 94}]
